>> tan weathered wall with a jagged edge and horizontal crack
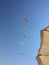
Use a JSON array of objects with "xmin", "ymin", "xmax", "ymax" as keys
[{"xmin": 36, "ymin": 27, "xmax": 49, "ymax": 65}]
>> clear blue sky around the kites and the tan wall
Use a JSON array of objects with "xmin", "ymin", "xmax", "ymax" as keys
[{"xmin": 0, "ymin": 0, "xmax": 49, "ymax": 65}]
